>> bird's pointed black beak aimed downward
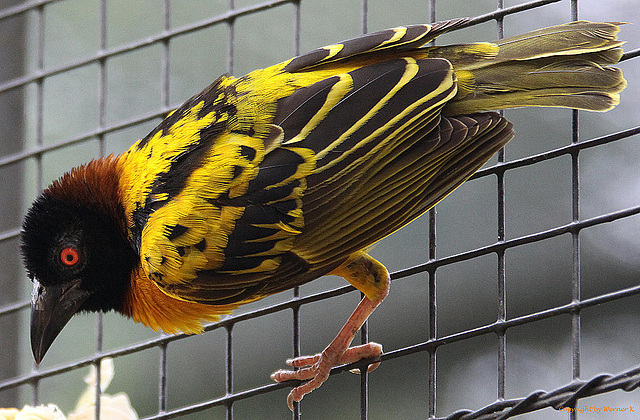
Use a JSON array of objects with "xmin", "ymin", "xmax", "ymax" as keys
[{"xmin": 31, "ymin": 279, "xmax": 91, "ymax": 363}]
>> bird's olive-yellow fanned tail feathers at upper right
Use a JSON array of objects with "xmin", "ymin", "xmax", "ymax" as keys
[{"xmin": 438, "ymin": 21, "xmax": 627, "ymax": 115}]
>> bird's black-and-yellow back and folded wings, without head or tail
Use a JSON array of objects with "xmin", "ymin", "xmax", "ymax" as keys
[{"xmin": 121, "ymin": 20, "xmax": 511, "ymax": 305}]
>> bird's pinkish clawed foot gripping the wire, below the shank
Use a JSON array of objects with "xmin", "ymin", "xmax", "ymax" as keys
[{"xmin": 271, "ymin": 343, "xmax": 382, "ymax": 410}]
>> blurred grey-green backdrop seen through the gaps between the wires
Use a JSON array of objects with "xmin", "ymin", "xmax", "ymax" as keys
[{"xmin": 0, "ymin": 0, "xmax": 640, "ymax": 420}]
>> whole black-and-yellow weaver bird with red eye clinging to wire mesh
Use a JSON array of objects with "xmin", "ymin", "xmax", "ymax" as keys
[{"xmin": 22, "ymin": 19, "xmax": 626, "ymax": 408}]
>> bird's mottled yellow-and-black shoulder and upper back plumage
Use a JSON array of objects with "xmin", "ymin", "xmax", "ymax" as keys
[{"xmin": 120, "ymin": 73, "xmax": 314, "ymax": 296}]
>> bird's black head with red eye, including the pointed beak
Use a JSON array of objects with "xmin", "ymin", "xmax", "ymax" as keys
[{"xmin": 21, "ymin": 159, "xmax": 137, "ymax": 363}]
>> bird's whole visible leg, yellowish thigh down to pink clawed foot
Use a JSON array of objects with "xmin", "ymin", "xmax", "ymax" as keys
[{"xmin": 271, "ymin": 252, "xmax": 390, "ymax": 409}]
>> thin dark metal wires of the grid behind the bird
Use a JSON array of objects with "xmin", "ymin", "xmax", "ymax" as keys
[{"xmin": 0, "ymin": 0, "xmax": 640, "ymax": 419}]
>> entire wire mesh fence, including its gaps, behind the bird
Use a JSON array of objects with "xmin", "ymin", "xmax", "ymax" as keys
[{"xmin": 0, "ymin": 0, "xmax": 640, "ymax": 419}]
